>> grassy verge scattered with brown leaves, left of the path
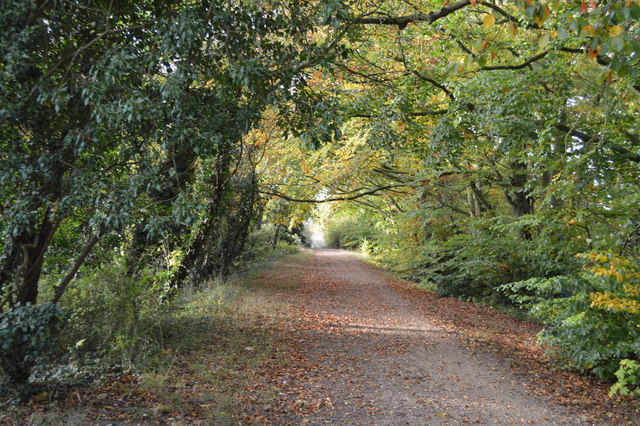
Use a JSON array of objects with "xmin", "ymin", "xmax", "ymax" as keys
[{"xmin": 0, "ymin": 252, "xmax": 308, "ymax": 425}]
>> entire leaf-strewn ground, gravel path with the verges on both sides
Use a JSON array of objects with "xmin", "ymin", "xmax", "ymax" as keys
[{"xmin": 7, "ymin": 250, "xmax": 640, "ymax": 425}]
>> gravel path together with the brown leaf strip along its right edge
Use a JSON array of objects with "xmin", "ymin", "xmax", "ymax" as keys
[{"xmin": 274, "ymin": 250, "xmax": 640, "ymax": 424}]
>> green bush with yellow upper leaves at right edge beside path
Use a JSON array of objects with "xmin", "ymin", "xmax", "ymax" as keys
[{"xmin": 502, "ymin": 253, "xmax": 640, "ymax": 380}]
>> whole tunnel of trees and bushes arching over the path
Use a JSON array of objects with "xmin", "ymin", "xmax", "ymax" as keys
[{"xmin": 0, "ymin": 0, "xmax": 640, "ymax": 400}]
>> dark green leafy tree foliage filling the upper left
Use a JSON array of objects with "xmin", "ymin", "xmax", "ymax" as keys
[{"xmin": 0, "ymin": 1, "xmax": 339, "ymax": 307}]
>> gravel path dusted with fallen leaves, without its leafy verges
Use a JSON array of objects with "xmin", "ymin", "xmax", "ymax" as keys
[{"xmin": 283, "ymin": 250, "xmax": 586, "ymax": 425}]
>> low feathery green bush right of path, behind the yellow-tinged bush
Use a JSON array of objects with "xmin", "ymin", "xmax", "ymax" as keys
[{"xmin": 394, "ymin": 216, "xmax": 576, "ymax": 304}]
